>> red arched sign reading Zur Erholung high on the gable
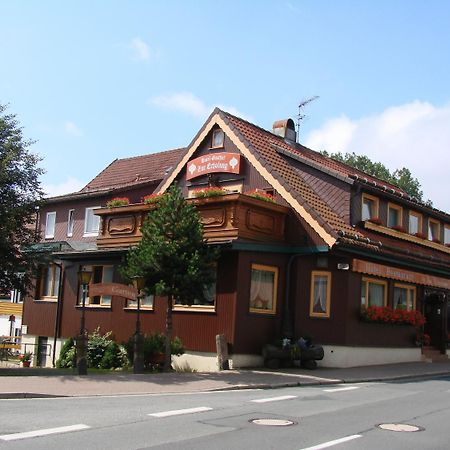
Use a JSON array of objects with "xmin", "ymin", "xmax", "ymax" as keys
[{"xmin": 186, "ymin": 153, "xmax": 241, "ymax": 180}]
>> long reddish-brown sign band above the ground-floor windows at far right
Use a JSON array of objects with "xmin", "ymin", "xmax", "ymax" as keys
[{"xmin": 352, "ymin": 259, "xmax": 450, "ymax": 289}]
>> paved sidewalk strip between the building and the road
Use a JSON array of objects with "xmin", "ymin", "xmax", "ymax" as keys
[{"xmin": 0, "ymin": 361, "xmax": 450, "ymax": 399}]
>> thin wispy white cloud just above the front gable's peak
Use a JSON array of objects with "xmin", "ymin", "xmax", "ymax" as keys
[{"xmin": 148, "ymin": 92, "xmax": 251, "ymax": 120}]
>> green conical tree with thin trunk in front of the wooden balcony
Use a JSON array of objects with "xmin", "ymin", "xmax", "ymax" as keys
[{"xmin": 122, "ymin": 185, "xmax": 218, "ymax": 370}]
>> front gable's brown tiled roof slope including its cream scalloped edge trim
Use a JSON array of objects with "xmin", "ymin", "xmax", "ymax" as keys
[{"xmin": 157, "ymin": 108, "xmax": 360, "ymax": 247}]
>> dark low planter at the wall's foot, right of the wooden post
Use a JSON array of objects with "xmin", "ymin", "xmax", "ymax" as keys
[{"xmin": 262, "ymin": 337, "xmax": 324, "ymax": 369}]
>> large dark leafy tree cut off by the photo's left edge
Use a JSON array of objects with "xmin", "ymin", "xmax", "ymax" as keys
[{"xmin": 0, "ymin": 104, "xmax": 44, "ymax": 291}]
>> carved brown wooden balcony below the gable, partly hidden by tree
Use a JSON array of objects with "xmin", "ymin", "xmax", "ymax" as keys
[{"xmin": 95, "ymin": 194, "xmax": 289, "ymax": 248}]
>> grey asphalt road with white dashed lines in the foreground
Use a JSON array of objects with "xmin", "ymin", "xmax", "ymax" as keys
[{"xmin": 0, "ymin": 377, "xmax": 450, "ymax": 450}]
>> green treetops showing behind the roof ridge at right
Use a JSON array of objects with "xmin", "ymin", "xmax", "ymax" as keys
[{"xmin": 321, "ymin": 151, "xmax": 432, "ymax": 206}]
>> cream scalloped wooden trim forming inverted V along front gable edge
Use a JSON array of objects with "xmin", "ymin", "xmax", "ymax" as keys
[{"xmin": 158, "ymin": 113, "xmax": 336, "ymax": 247}]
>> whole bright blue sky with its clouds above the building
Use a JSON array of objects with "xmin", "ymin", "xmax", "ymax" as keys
[{"xmin": 0, "ymin": 0, "xmax": 450, "ymax": 212}]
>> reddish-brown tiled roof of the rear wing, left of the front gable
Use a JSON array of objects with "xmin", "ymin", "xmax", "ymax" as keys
[{"xmin": 80, "ymin": 148, "xmax": 186, "ymax": 192}]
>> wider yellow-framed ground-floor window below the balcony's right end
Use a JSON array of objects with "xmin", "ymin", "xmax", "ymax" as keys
[{"xmin": 250, "ymin": 264, "xmax": 278, "ymax": 314}]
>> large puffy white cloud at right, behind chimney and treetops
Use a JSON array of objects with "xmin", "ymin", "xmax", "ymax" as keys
[{"xmin": 305, "ymin": 100, "xmax": 450, "ymax": 212}]
